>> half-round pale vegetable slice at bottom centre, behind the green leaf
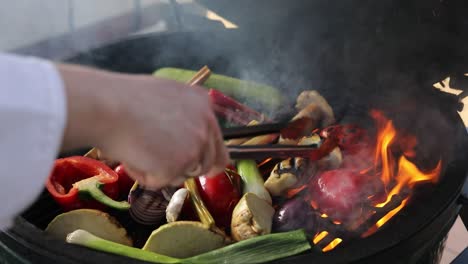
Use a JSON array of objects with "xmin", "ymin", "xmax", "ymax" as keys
[{"xmin": 143, "ymin": 221, "xmax": 226, "ymax": 258}]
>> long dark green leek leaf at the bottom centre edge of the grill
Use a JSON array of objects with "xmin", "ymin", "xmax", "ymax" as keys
[{"xmin": 182, "ymin": 230, "xmax": 311, "ymax": 264}]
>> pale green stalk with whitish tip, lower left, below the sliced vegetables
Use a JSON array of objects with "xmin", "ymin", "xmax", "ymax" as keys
[{"xmin": 67, "ymin": 229, "xmax": 181, "ymax": 264}]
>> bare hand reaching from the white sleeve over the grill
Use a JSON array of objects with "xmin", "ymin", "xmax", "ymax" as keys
[{"xmin": 59, "ymin": 65, "xmax": 228, "ymax": 189}]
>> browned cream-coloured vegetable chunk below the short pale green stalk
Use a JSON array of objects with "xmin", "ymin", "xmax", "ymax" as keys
[{"xmin": 231, "ymin": 193, "xmax": 275, "ymax": 241}]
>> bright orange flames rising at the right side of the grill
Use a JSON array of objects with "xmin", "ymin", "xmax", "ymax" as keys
[{"xmin": 310, "ymin": 110, "xmax": 442, "ymax": 252}]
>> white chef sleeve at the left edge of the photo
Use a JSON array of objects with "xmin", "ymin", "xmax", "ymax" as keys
[{"xmin": 0, "ymin": 53, "xmax": 66, "ymax": 229}]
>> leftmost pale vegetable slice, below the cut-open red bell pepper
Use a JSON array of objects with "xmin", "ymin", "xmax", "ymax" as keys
[{"xmin": 45, "ymin": 209, "xmax": 132, "ymax": 246}]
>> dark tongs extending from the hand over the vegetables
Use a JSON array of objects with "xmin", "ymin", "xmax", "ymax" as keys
[{"xmin": 222, "ymin": 118, "xmax": 338, "ymax": 160}]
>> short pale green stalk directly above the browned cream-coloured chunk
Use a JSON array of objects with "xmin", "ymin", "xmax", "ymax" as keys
[{"xmin": 237, "ymin": 160, "xmax": 271, "ymax": 204}]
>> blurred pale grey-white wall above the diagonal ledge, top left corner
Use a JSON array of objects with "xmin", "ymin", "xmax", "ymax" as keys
[{"xmin": 0, "ymin": 0, "xmax": 169, "ymax": 51}]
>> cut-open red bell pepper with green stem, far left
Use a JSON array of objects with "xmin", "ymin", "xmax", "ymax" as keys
[{"xmin": 46, "ymin": 156, "xmax": 130, "ymax": 211}]
